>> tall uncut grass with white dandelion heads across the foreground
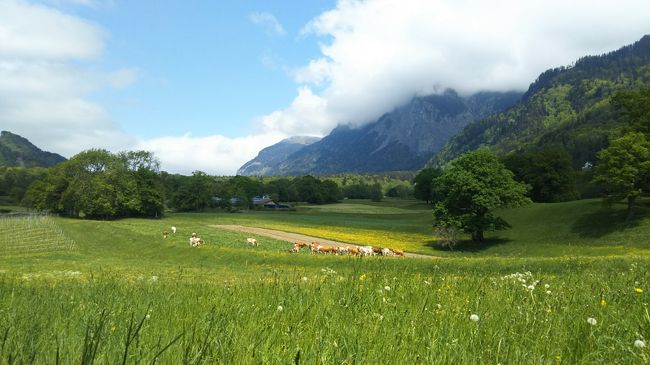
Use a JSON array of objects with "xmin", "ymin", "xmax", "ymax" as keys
[{"xmin": 0, "ymin": 260, "xmax": 650, "ymax": 364}]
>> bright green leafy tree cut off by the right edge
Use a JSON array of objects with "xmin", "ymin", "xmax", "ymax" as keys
[{"xmin": 595, "ymin": 132, "xmax": 650, "ymax": 220}]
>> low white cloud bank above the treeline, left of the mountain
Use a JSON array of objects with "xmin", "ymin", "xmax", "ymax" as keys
[{"xmin": 135, "ymin": 133, "xmax": 286, "ymax": 175}]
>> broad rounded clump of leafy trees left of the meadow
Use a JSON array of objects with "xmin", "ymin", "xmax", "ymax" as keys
[{"xmin": 25, "ymin": 149, "xmax": 163, "ymax": 219}]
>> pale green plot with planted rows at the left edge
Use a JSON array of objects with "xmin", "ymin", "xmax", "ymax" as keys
[{"xmin": 0, "ymin": 214, "xmax": 74, "ymax": 256}]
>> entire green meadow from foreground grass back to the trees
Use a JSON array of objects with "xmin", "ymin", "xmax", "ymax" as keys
[{"xmin": 0, "ymin": 200, "xmax": 650, "ymax": 364}]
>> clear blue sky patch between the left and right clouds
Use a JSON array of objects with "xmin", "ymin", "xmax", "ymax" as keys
[{"xmin": 62, "ymin": 0, "xmax": 335, "ymax": 138}]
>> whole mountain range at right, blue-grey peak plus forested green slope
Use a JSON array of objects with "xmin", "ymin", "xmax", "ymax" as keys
[{"xmin": 242, "ymin": 35, "xmax": 650, "ymax": 175}]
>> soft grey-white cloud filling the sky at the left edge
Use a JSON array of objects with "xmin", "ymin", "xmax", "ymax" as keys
[{"xmin": 0, "ymin": 0, "xmax": 137, "ymax": 157}]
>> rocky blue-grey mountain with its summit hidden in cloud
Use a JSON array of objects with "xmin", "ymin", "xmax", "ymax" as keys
[{"xmin": 273, "ymin": 90, "xmax": 521, "ymax": 175}]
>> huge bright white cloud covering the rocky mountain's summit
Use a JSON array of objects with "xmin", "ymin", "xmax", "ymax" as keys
[{"xmin": 260, "ymin": 0, "xmax": 650, "ymax": 134}]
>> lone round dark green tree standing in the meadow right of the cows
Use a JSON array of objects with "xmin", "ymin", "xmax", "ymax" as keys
[{"xmin": 433, "ymin": 149, "xmax": 530, "ymax": 242}]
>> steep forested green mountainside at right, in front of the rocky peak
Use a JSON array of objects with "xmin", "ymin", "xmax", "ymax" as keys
[{"xmin": 428, "ymin": 35, "xmax": 650, "ymax": 167}]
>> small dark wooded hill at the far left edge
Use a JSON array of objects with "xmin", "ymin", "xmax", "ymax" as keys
[{"xmin": 0, "ymin": 131, "xmax": 66, "ymax": 167}]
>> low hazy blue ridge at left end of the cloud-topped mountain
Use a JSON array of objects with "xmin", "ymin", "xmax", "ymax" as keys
[{"xmin": 237, "ymin": 136, "xmax": 320, "ymax": 176}]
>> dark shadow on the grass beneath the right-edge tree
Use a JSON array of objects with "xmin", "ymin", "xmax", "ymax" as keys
[{"xmin": 571, "ymin": 205, "xmax": 647, "ymax": 238}]
